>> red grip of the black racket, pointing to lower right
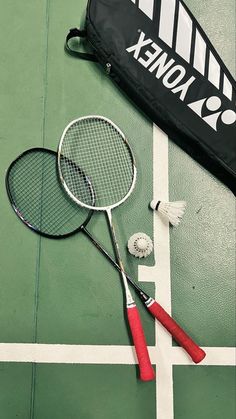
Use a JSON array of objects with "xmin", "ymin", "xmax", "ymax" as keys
[{"xmin": 147, "ymin": 300, "xmax": 206, "ymax": 364}]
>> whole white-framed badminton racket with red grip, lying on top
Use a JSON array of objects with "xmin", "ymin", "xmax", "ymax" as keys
[{"xmin": 58, "ymin": 116, "xmax": 155, "ymax": 381}]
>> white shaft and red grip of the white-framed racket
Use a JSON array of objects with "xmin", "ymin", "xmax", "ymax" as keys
[{"xmin": 106, "ymin": 210, "xmax": 155, "ymax": 381}]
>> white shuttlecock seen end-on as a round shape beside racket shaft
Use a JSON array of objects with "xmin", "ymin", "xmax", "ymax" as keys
[{"xmin": 128, "ymin": 233, "xmax": 153, "ymax": 258}]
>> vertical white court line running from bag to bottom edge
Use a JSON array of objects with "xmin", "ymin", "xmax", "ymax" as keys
[{"xmin": 152, "ymin": 125, "xmax": 174, "ymax": 419}]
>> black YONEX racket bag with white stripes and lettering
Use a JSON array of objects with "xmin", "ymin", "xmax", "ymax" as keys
[{"xmin": 66, "ymin": 0, "xmax": 236, "ymax": 193}]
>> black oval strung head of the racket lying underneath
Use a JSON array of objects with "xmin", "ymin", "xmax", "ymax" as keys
[{"xmin": 5, "ymin": 147, "xmax": 94, "ymax": 239}]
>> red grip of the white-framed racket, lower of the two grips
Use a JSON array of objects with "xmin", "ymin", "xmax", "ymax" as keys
[{"xmin": 127, "ymin": 306, "xmax": 155, "ymax": 381}]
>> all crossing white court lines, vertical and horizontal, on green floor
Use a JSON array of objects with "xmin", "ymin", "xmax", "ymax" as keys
[{"xmin": 0, "ymin": 126, "xmax": 236, "ymax": 419}]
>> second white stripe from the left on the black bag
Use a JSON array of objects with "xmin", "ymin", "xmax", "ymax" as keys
[{"xmin": 159, "ymin": 0, "xmax": 176, "ymax": 47}]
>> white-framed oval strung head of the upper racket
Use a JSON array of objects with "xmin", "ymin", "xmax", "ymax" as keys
[{"xmin": 57, "ymin": 115, "xmax": 137, "ymax": 211}]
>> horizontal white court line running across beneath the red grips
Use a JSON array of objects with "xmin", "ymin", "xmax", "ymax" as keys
[{"xmin": 0, "ymin": 343, "xmax": 236, "ymax": 368}]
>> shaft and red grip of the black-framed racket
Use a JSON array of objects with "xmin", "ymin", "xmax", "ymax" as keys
[{"xmin": 82, "ymin": 228, "xmax": 206, "ymax": 363}]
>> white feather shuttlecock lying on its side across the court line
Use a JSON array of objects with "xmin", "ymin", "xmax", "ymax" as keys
[{"xmin": 150, "ymin": 200, "xmax": 187, "ymax": 227}]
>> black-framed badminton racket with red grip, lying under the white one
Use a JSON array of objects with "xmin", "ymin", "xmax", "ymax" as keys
[{"xmin": 6, "ymin": 148, "xmax": 205, "ymax": 362}]
